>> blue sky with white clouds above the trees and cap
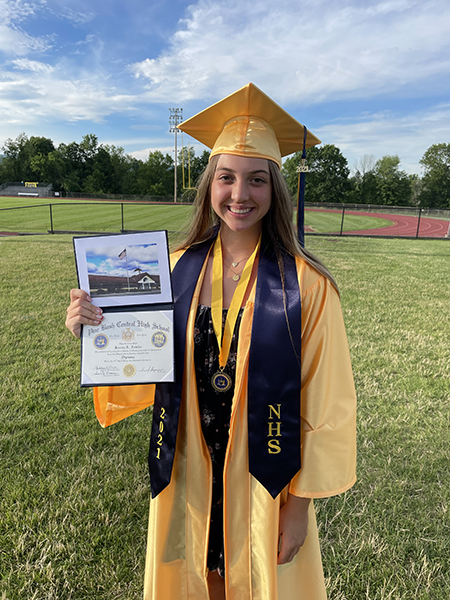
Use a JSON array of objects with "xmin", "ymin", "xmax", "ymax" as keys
[{"xmin": 0, "ymin": 0, "xmax": 450, "ymax": 175}]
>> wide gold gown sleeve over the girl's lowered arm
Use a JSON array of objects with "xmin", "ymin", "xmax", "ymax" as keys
[{"xmin": 289, "ymin": 276, "xmax": 356, "ymax": 498}]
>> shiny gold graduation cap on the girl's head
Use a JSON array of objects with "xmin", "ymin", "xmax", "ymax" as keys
[{"xmin": 178, "ymin": 83, "xmax": 320, "ymax": 168}]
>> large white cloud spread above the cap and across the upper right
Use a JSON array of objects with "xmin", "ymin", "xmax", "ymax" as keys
[{"xmin": 130, "ymin": 0, "xmax": 450, "ymax": 104}]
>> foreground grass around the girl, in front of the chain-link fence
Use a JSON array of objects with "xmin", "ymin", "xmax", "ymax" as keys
[{"xmin": 0, "ymin": 235, "xmax": 450, "ymax": 600}]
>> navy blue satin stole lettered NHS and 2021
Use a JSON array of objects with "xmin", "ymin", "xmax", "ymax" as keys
[{"xmin": 149, "ymin": 236, "xmax": 301, "ymax": 498}]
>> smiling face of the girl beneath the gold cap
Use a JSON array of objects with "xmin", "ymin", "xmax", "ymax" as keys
[{"xmin": 211, "ymin": 154, "xmax": 272, "ymax": 234}]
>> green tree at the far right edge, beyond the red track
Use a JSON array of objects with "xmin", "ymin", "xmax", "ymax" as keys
[{"xmin": 419, "ymin": 144, "xmax": 450, "ymax": 208}]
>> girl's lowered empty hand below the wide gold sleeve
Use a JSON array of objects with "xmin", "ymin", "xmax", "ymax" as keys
[{"xmin": 277, "ymin": 494, "xmax": 310, "ymax": 565}]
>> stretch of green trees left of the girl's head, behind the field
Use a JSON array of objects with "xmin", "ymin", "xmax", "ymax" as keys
[{"xmin": 0, "ymin": 133, "xmax": 209, "ymax": 197}]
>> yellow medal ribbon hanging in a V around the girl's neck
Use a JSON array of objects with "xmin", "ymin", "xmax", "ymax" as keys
[{"xmin": 211, "ymin": 233, "xmax": 261, "ymax": 371}]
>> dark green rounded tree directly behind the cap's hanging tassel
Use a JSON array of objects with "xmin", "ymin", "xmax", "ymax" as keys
[{"xmin": 282, "ymin": 144, "xmax": 351, "ymax": 202}]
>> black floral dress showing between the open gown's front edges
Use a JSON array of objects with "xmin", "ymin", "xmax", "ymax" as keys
[{"xmin": 194, "ymin": 305, "xmax": 243, "ymax": 577}]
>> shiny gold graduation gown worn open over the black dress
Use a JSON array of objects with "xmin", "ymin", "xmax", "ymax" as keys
[{"xmin": 94, "ymin": 253, "xmax": 356, "ymax": 600}]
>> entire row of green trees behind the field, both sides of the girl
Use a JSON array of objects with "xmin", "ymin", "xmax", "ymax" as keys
[{"xmin": 0, "ymin": 133, "xmax": 450, "ymax": 208}]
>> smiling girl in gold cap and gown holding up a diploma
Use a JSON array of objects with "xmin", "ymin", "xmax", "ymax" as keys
[{"xmin": 66, "ymin": 84, "xmax": 356, "ymax": 600}]
